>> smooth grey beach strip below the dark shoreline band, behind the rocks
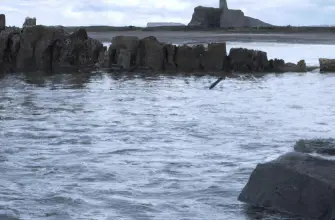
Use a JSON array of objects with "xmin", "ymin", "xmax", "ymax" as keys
[{"xmin": 88, "ymin": 31, "xmax": 335, "ymax": 44}]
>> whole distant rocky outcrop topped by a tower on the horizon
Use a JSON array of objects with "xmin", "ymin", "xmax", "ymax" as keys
[{"xmin": 188, "ymin": 0, "xmax": 272, "ymax": 28}]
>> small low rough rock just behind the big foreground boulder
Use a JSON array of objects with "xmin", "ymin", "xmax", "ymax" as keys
[{"xmin": 294, "ymin": 138, "xmax": 335, "ymax": 155}]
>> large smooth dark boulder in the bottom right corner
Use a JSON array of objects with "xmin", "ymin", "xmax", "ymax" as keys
[{"xmin": 238, "ymin": 152, "xmax": 335, "ymax": 220}]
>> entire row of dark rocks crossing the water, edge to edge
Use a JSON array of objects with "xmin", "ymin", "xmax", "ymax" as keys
[{"xmin": 0, "ymin": 25, "xmax": 335, "ymax": 75}]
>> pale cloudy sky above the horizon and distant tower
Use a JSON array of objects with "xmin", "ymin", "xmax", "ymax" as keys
[{"xmin": 0, "ymin": 0, "xmax": 335, "ymax": 26}]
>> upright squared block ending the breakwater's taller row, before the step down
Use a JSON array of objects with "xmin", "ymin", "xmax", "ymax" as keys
[{"xmin": 202, "ymin": 43, "xmax": 227, "ymax": 72}]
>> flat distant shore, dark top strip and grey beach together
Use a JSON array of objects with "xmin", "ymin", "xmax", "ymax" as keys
[{"xmin": 57, "ymin": 26, "xmax": 335, "ymax": 44}]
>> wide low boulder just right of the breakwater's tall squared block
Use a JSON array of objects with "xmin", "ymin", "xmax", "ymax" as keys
[{"xmin": 229, "ymin": 48, "xmax": 269, "ymax": 73}]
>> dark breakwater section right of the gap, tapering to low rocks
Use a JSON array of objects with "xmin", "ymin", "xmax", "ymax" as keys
[{"xmin": 101, "ymin": 36, "xmax": 307, "ymax": 74}]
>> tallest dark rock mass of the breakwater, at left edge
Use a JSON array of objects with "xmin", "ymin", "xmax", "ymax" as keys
[{"xmin": 0, "ymin": 25, "xmax": 106, "ymax": 73}]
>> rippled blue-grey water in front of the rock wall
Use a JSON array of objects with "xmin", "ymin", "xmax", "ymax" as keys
[{"xmin": 0, "ymin": 42, "xmax": 335, "ymax": 220}]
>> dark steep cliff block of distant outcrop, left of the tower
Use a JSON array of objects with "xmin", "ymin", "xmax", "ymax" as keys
[{"xmin": 188, "ymin": 6, "xmax": 222, "ymax": 28}]
